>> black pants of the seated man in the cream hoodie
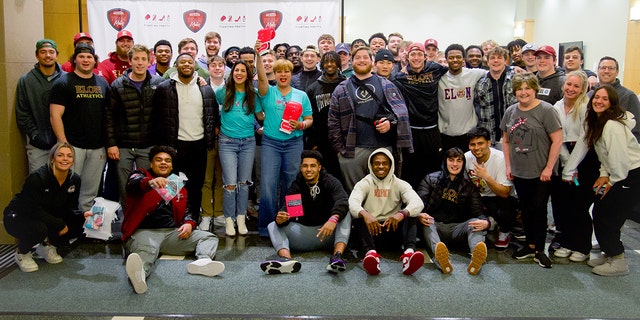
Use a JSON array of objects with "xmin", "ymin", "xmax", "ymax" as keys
[{"xmin": 353, "ymin": 218, "xmax": 418, "ymax": 253}]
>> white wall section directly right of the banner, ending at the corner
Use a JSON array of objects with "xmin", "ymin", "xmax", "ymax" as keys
[{"xmin": 344, "ymin": 0, "xmax": 516, "ymax": 50}]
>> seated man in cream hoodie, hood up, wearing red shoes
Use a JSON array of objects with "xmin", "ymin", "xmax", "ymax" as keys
[{"xmin": 349, "ymin": 148, "xmax": 424, "ymax": 275}]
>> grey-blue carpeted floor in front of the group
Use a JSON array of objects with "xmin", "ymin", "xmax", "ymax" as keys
[{"xmin": 0, "ymin": 223, "xmax": 640, "ymax": 319}]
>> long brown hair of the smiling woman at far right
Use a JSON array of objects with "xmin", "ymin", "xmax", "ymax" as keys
[{"xmin": 585, "ymin": 85, "xmax": 625, "ymax": 148}]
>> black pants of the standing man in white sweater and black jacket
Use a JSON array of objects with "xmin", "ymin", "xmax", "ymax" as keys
[{"xmin": 173, "ymin": 139, "xmax": 207, "ymax": 221}]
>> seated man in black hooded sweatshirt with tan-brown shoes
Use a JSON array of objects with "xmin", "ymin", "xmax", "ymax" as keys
[{"xmin": 418, "ymin": 147, "xmax": 490, "ymax": 274}]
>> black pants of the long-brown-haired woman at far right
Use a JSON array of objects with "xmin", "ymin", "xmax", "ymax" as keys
[{"xmin": 593, "ymin": 168, "xmax": 640, "ymax": 257}]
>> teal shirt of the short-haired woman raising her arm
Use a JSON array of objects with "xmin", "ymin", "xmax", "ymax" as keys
[{"xmin": 259, "ymin": 86, "xmax": 312, "ymax": 141}]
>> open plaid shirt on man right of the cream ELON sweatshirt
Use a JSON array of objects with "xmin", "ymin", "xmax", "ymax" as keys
[{"xmin": 473, "ymin": 67, "xmax": 518, "ymax": 145}]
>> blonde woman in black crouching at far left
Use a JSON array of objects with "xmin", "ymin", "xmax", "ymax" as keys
[{"xmin": 4, "ymin": 142, "xmax": 84, "ymax": 272}]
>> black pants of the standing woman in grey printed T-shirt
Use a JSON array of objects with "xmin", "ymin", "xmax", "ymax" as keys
[{"xmin": 513, "ymin": 177, "xmax": 551, "ymax": 251}]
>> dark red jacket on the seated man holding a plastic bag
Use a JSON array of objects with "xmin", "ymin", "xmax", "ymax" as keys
[{"xmin": 122, "ymin": 169, "xmax": 196, "ymax": 241}]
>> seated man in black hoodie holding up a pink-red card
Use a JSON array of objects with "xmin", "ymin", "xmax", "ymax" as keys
[{"xmin": 260, "ymin": 150, "xmax": 351, "ymax": 274}]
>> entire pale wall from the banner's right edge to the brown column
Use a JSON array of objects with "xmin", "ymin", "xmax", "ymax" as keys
[{"xmin": 344, "ymin": 0, "xmax": 629, "ymax": 77}]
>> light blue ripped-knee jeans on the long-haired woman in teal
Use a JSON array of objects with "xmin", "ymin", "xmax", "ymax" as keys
[{"xmin": 218, "ymin": 133, "xmax": 256, "ymax": 219}]
